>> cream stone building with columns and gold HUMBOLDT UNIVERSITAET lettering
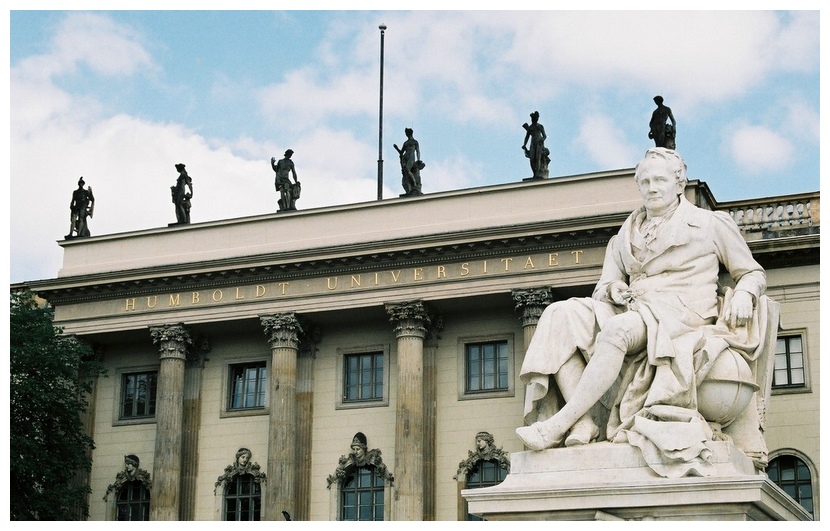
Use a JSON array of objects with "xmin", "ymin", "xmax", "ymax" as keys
[{"xmin": 24, "ymin": 169, "xmax": 820, "ymax": 521}]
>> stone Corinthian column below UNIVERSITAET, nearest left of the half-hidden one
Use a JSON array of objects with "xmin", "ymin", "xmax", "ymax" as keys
[{"xmin": 386, "ymin": 301, "xmax": 430, "ymax": 521}]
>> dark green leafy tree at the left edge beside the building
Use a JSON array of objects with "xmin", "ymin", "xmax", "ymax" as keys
[{"xmin": 9, "ymin": 291, "xmax": 101, "ymax": 520}]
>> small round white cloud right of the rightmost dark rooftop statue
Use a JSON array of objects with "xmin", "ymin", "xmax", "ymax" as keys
[{"xmin": 728, "ymin": 125, "xmax": 793, "ymax": 173}]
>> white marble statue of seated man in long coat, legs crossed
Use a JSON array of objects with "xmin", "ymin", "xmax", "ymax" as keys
[{"xmin": 516, "ymin": 148, "xmax": 766, "ymax": 478}]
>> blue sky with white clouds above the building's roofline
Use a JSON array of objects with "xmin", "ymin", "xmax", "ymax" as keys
[{"xmin": 9, "ymin": 5, "xmax": 820, "ymax": 282}]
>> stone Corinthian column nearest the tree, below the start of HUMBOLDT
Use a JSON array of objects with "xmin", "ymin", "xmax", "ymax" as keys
[{"xmin": 150, "ymin": 324, "xmax": 191, "ymax": 521}]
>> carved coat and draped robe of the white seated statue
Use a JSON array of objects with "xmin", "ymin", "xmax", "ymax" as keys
[{"xmin": 521, "ymin": 196, "xmax": 766, "ymax": 477}]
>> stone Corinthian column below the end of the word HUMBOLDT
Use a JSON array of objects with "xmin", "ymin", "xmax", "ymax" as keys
[{"xmin": 260, "ymin": 312, "xmax": 302, "ymax": 521}]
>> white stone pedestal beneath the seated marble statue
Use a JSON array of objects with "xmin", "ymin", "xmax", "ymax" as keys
[{"xmin": 461, "ymin": 442, "xmax": 812, "ymax": 521}]
